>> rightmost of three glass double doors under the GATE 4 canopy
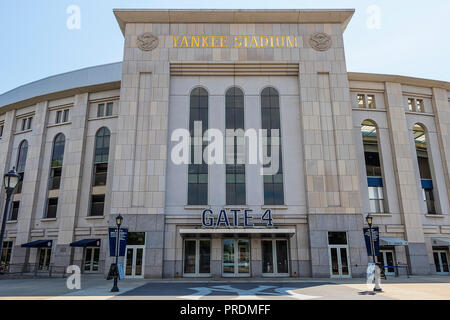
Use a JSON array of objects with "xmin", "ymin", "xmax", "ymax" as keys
[{"xmin": 261, "ymin": 239, "xmax": 289, "ymax": 277}]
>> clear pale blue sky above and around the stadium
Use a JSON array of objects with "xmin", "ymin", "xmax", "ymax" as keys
[{"xmin": 0, "ymin": 0, "xmax": 450, "ymax": 93}]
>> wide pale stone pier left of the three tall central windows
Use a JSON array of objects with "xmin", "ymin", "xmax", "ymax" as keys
[{"xmin": 109, "ymin": 24, "xmax": 170, "ymax": 278}]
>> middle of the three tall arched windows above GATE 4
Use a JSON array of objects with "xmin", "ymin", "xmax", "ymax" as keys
[{"xmin": 225, "ymin": 88, "xmax": 246, "ymax": 205}]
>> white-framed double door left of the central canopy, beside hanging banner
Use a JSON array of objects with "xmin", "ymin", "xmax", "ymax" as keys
[{"xmin": 124, "ymin": 232, "xmax": 145, "ymax": 278}]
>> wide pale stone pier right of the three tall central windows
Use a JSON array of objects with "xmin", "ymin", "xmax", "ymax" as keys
[{"xmin": 299, "ymin": 45, "xmax": 367, "ymax": 277}]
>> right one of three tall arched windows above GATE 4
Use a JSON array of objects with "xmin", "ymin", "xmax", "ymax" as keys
[{"xmin": 261, "ymin": 87, "xmax": 284, "ymax": 205}]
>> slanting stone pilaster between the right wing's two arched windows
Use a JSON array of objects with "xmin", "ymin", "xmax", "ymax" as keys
[{"xmin": 385, "ymin": 82, "xmax": 430, "ymax": 274}]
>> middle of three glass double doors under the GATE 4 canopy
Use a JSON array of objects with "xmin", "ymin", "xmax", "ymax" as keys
[{"xmin": 222, "ymin": 239, "xmax": 250, "ymax": 277}]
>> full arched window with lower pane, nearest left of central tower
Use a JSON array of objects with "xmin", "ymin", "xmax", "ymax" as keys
[{"xmin": 90, "ymin": 127, "xmax": 111, "ymax": 216}]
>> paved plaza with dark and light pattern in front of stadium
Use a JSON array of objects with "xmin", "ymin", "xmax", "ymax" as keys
[{"xmin": 0, "ymin": 275, "xmax": 450, "ymax": 300}]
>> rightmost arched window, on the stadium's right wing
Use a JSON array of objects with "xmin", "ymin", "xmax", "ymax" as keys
[{"xmin": 413, "ymin": 123, "xmax": 436, "ymax": 214}]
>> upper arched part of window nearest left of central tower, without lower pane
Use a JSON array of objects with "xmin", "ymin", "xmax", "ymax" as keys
[{"xmin": 94, "ymin": 127, "xmax": 111, "ymax": 186}]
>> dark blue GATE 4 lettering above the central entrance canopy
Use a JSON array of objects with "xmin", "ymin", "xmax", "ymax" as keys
[{"xmin": 202, "ymin": 209, "xmax": 273, "ymax": 228}]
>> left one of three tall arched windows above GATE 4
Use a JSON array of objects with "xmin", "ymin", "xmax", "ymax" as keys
[{"xmin": 188, "ymin": 88, "xmax": 208, "ymax": 205}]
